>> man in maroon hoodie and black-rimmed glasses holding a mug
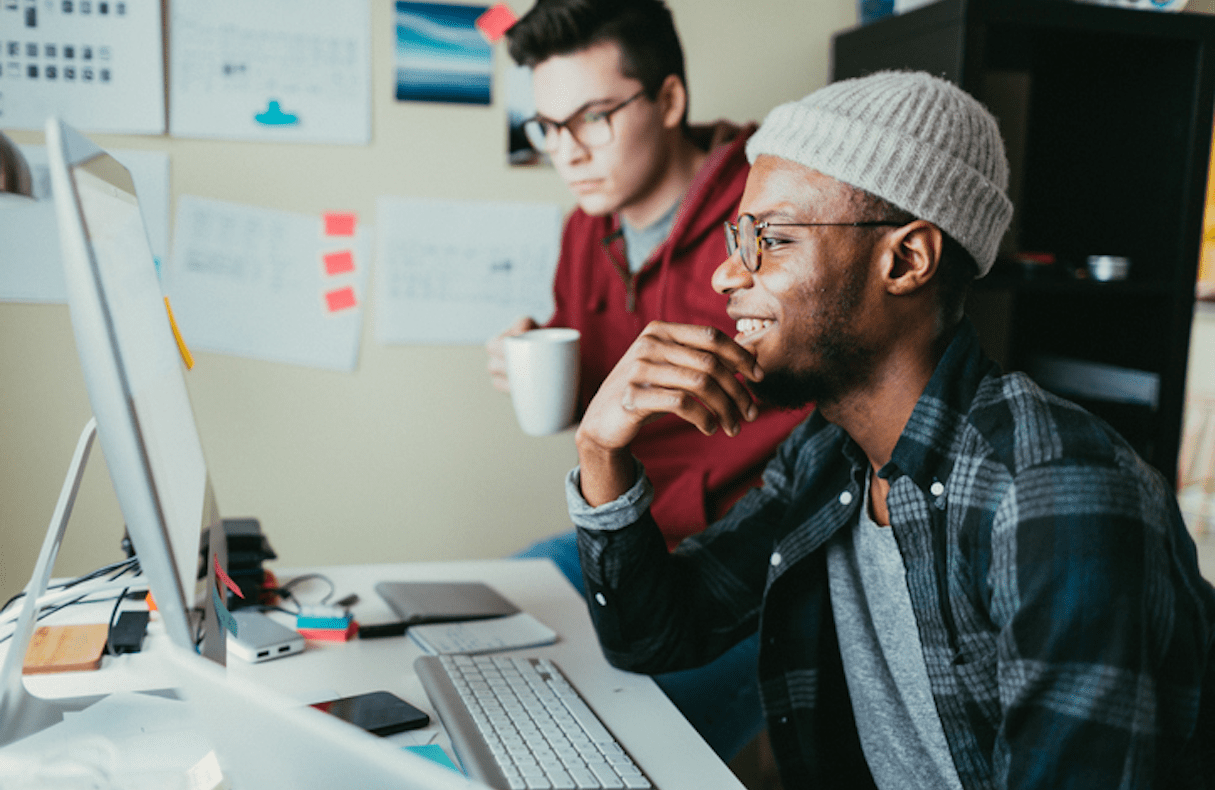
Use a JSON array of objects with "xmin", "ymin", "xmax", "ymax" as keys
[{"xmin": 490, "ymin": 0, "xmax": 809, "ymax": 760}]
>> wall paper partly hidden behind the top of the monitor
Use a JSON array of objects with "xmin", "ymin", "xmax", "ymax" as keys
[{"xmin": 0, "ymin": 146, "xmax": 169, "ymax": 304}]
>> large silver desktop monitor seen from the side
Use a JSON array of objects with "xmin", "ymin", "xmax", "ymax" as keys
[{"xmin": 46, "ymin": 118, "xmax": 226, "ymax": 664}]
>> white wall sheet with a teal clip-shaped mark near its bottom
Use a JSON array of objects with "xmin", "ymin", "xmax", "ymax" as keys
[{"xmin": 169, "ymin": 0, "xmax": 372, "ymax": 145}]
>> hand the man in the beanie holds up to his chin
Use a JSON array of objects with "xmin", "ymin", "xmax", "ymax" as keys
[{"xmin": 575, "ymin": 321, "xmax": 763, "ymax": 507}]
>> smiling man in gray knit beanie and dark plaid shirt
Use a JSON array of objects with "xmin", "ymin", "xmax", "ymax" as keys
[{"xmin": 566, "ymin": 72, "xmax": 1215, "ymax": 790}]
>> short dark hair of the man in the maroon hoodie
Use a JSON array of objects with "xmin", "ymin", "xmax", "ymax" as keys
[{"xmin": 507, "ymin": 0, "xmax": 688, "ymax": 110}]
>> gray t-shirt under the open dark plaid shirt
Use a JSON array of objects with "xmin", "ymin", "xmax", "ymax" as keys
[{"xmin": 826, "ymin": 476, "xmax": 962, "ymax": 790}]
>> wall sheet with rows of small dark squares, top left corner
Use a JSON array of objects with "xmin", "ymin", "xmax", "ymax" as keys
[{"xmin": 0, "ymin": 0, "xmax": 164, "ymax": 135}]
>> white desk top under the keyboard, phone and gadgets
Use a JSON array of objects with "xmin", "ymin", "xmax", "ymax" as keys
[{"xmin": 5, "ymin": 560, "xmax": 742, "ymax": 790}]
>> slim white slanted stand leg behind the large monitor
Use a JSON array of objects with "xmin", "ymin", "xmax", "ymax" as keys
[{"xmin": 0, "ymin": 419, "xmax": 110, "ymax": 746}]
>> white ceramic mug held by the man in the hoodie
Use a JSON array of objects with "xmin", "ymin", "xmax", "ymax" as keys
[{"xmin": 504, "ymin": 327, "xmax": 581, "ymax": 436}]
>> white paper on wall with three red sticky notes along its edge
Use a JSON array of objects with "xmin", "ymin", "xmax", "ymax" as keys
[{"xmin": 163, "ymin": 194, "xmax": 371, "ymax": 371}]
